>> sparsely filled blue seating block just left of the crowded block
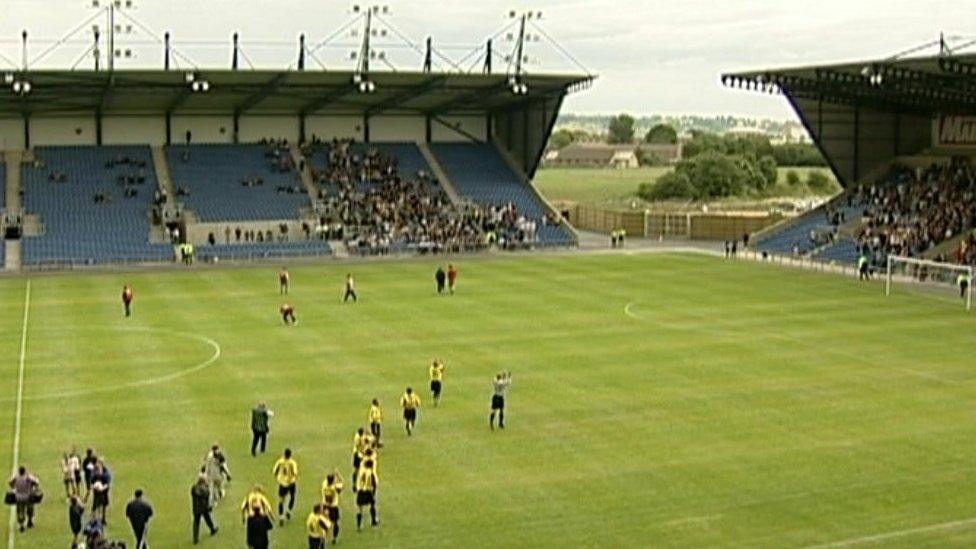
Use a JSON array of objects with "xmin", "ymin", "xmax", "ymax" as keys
[{"xmin": 166, "ymin": 143, "xmax": 309, "ymax": 221}]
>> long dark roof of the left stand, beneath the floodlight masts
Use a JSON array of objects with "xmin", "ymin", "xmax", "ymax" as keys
[{"xmin": 0, "ymin": 69, "xmax": 593, "ymax": 117}]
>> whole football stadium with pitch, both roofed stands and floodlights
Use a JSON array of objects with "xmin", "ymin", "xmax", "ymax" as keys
[{"xmin": 0, "ymin": 1, "xmax": 976, "ymax": 549}]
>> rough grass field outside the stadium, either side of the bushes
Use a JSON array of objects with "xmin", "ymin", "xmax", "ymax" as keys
[{"xmin": 533, "ymin": 167, "xmax": 838, "ymax": 204}]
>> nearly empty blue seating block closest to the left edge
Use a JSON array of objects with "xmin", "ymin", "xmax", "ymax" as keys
[{"xmin": 21, "ymin": 146, "xmax": 173, "ymax": 265}]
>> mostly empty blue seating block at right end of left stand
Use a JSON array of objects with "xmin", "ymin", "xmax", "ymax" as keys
[{"xmin": 431, "ymin": 143, "xmax": 574, "ymax": 246}]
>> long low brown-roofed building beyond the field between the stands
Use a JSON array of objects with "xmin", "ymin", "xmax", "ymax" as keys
[{"xmin": 545, "ymin": 143, "xmax": 681, "ymax": 169}]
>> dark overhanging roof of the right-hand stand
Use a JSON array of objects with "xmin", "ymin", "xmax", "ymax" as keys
[{"xmin": 722, "ymin": 54, "xmax": 976, "ymax": 115}]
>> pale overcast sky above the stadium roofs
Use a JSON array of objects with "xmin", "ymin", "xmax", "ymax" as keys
[{"xmin": 0, "ymin": 0, "xmax": 976, "ymax": 119}]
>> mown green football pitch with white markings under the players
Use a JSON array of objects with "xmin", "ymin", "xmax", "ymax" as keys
[{"xmin": 0, "ymin": 254, "xmax": 976, "ymax": 548}]
